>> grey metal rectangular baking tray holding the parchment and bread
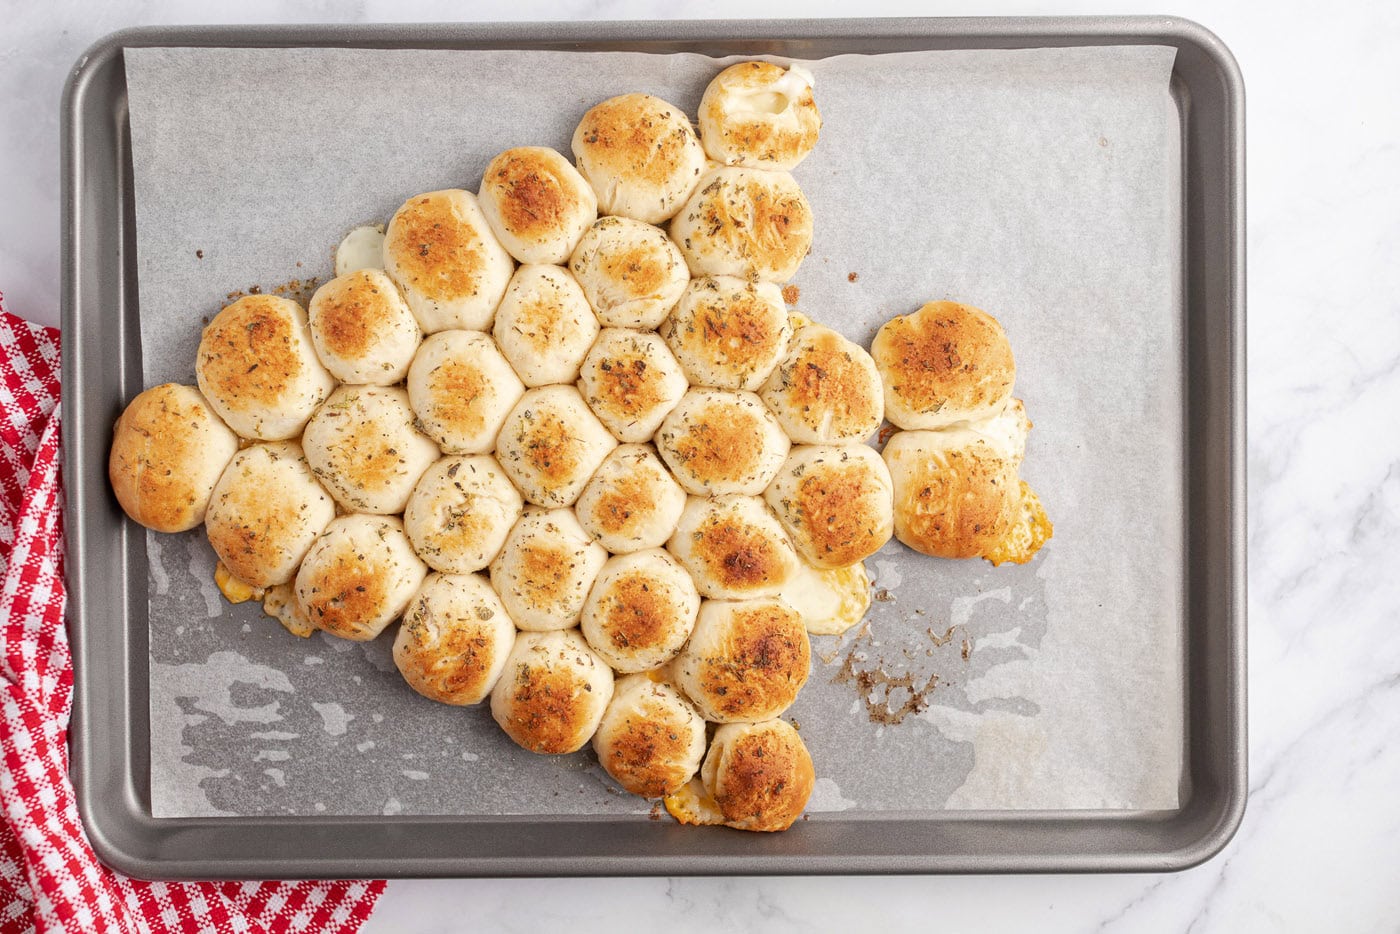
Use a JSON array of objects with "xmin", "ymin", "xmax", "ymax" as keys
[{"xmin": 62, "ymin": 17, "xmax": 1246, "ymax": 878}]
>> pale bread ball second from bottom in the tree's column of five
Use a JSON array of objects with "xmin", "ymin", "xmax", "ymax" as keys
[{"xmin": 491, "ymin": 510, "xmax": 608, "ymax": 632}]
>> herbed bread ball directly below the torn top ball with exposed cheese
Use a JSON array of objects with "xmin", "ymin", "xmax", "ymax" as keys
[{"xmin": 671, "ymin": 168, "xmax": 812, "ymax": 283}]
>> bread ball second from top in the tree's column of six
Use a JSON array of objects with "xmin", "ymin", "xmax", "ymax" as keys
[{"xmin": 568, "ymin": 217, "xmax": 690, "ymax": 328}]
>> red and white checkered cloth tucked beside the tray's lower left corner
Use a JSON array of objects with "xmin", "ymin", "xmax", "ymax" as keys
[{"xmin": 0, "ymin": 295, "xmax": 384, "ymax": 934}]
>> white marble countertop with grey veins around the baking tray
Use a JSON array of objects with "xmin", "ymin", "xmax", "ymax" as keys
[{"xmin": 0, "ymin": 0, "xmax": 1400, "ymax": 931}]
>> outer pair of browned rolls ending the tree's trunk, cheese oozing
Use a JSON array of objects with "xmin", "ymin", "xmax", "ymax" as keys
[{"xmin": 871, "ymin": 301, "xmax": 1053, "ymax": 564}]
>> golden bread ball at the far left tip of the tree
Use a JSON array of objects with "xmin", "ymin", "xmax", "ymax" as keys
[{"xmin": 108, "ymin": 382, "xmax": 238, "ymax": 532}]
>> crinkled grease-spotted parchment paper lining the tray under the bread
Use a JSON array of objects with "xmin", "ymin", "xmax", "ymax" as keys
[{"xmin": 126, "ymin": 48, "xmax": 1184, "ymax": 819}]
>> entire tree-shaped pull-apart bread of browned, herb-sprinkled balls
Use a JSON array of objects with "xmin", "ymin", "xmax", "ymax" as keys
[{"xmin": 109, "ymin": 62, "xmax": 1050, "ymax": 830}]
